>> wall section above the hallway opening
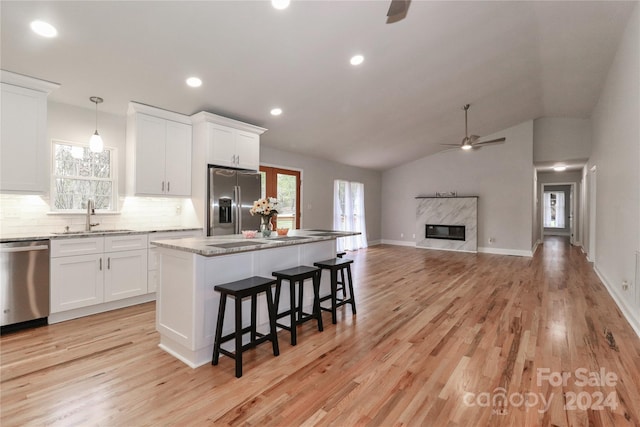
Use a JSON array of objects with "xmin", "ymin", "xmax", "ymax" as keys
[{"xmin": 533, "ymin": 117, "xmax": 591, "ymax": 163}]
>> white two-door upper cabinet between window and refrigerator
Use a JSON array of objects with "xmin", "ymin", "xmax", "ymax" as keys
[{"xmin": 127, "ymin": 102, "xmax": 191, "ymax": 197}]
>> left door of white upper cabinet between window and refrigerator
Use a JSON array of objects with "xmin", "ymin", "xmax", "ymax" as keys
[{"xmin": 135, "ymin": 113, "xmax": 166, "ymax": 195}]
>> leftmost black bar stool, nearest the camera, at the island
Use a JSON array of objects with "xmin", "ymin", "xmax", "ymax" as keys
[{"xmin": 211, "ymin": 276, "xmax": 280, "ymax": 378}]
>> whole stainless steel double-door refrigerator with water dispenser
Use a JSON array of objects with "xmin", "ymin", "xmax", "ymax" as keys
[{"xmin": 207, "ymin": 165, "xmax": 261, "ymax": 236}]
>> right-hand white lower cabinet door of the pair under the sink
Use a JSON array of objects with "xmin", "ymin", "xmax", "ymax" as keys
[{"xmin": 104, "ymin": 249, "xmax": 147, "ymax": 302}]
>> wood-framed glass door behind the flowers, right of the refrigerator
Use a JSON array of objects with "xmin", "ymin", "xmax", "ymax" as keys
[{"xmin": 260, "ymin": 166, "xmax": 302, "ymax": 229}]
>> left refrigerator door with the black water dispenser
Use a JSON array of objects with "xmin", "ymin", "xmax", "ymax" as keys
[{"xmin": 207, "ymin": 166, "xmax": 237, "ymax": 236}]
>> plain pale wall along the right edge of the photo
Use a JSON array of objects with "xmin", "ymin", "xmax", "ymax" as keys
[{"xmin": 589, "ymin": 5, "xmax": 640, "ymax": 335}]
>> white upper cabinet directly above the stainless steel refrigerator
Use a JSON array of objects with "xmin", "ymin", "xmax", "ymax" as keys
[{"xmin": 191, "ymin": 112, "xmax": 266, "ymax": 170}]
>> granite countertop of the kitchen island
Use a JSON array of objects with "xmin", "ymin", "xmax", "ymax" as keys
[{"xmin": 150, "ymin": 230, "xmax": 360, "ymax": 257}]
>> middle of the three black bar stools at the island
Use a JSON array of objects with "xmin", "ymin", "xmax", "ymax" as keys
[{"xmin": 271, "ymin": 265, "xmax": 323, "ymax": 345}]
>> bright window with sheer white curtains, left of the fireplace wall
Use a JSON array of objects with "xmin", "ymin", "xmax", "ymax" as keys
[{"xmin": 333, "ymin": 179, "xmax": 367, "ymax": 251}]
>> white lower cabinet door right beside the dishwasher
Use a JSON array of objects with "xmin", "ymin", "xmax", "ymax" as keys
[{"xmin": 51, "ymin": 255, "xmax": 105, "ymax": 313}]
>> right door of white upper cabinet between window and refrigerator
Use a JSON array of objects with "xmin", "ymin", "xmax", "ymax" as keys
[{"xmin": 165, "ymin": 120, "xmax": 191, "ymax": 196}]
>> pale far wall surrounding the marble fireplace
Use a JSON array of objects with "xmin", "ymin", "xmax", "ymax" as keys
[{"xmin": 381, "ymin": 121, "xmax": 534, "ymax": 255}]
